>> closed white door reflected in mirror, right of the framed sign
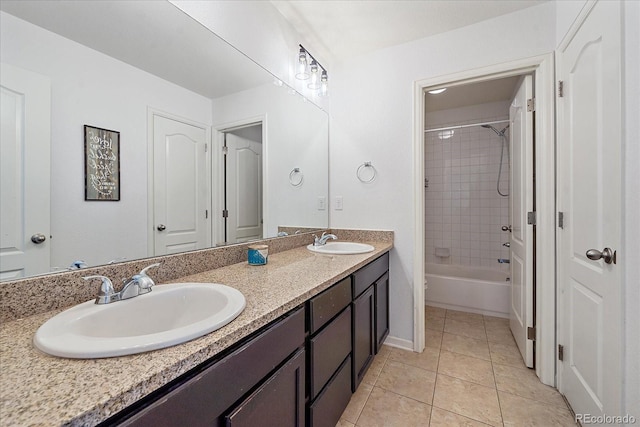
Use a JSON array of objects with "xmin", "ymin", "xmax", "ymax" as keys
[{"xmin": 152, "ymin": 115, "xmax": 211, "ymax": 255}]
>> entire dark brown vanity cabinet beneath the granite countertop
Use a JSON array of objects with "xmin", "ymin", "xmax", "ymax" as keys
[{"xmin": 100, "ymin": 253, "xmax": 389, "ymax": 427}]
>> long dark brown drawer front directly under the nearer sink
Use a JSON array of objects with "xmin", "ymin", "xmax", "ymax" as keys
[{"xmin": 119, "ymin": 309, "xmax": 305, "ymax": 427}]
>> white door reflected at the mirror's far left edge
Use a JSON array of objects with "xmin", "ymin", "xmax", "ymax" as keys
[{"xmin": 0, "ymin": 64, "xmax": 51, "ymax": 280}]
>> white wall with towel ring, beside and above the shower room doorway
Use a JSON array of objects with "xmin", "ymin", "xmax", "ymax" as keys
[{"xmin": 330, "ymin": 2, "xmax": 555, "ymax": 342}]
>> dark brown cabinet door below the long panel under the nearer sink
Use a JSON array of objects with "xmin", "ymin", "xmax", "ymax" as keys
[{"xmin": 225, "ymin": 350, "xmax": 305, "ymax": 427}]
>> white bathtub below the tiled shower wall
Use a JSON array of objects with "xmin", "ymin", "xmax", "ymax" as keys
[{"xmin": 425, "ymin": 263, "xmax": 511, "ymax": 318}]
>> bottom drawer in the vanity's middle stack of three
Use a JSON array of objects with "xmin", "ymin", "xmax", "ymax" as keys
[{"xmin": 309, "ymin": 356, "xmax": 351, "ymax": 427}]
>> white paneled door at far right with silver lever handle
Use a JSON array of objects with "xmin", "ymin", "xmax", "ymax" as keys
[{"xmin": 557, "ymin": 1, "xmax": 624, "ymax": 416}]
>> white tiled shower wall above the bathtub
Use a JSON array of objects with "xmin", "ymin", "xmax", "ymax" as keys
[{"xmin": 425, "ymin": 101, "xmax": 509, "ymax": 270}]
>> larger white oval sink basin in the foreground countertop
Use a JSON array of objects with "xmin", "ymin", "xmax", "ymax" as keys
[{"xmin": 33, "ymin": 283, "xmax": 245, "ymax": 359}]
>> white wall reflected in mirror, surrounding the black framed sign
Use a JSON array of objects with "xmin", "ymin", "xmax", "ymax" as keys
[{"xmin": 0, "ymin": 12, "xmax": 212, "ymax": 267}]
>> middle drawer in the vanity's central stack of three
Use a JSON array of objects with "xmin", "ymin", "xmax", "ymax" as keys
[{"xmin": 309, "ymin": 307, "xmax": 351, "ymax": 399}]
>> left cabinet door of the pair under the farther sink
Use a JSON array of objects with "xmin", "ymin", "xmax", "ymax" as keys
[{"xmin": 352, "ymin": 285, "xmax": 375, "ymax": 392}]
